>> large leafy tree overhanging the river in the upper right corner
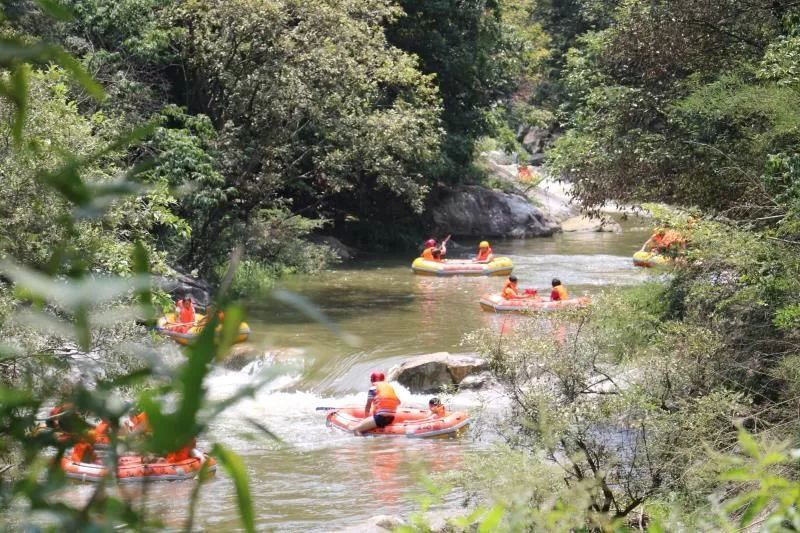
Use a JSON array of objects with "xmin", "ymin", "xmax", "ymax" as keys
[{"xmin": 548, "ymin": 0, "xmax": 798, "ymax": 218}]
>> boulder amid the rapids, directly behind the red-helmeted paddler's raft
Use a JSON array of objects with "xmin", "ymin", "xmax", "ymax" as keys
[{"xmin": 386, "ymin": 352, "xmax": 488, "ymax": 393}]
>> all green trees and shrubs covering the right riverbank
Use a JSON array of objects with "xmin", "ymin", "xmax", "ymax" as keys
[{"xmin": 438, "ymin": 0, "xmax": 800, "ymax": 530}]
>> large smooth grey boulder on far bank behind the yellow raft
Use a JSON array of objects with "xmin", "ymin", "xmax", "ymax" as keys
[{"xmin": 433, "ymin": 185, "xmax": 560, "ymax": 238}]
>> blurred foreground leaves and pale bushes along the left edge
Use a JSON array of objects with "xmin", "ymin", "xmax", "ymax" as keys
[{"xmin": 0, "ymin": 10, "xmax": 282, "ymax": 531}]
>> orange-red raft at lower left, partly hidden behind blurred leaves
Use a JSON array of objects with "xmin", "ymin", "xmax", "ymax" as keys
[{"xmin": 61, "ymin": 449, "xmax": 217, "ymax": 483}]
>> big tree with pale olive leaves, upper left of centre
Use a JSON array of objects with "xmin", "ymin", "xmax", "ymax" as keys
[{"xmin": 170, "ymin": 0, "xmax": 439, "ymax": 233}]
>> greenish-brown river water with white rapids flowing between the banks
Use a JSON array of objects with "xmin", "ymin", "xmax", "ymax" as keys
[{"xmin": 62, "ymin": 218, "xmax": 648, "ymax": 531}]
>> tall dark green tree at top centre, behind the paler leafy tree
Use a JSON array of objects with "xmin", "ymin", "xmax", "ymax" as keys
[{"xmin": 388, "ymin": 0, "xmax": 546, "ymax": 181}]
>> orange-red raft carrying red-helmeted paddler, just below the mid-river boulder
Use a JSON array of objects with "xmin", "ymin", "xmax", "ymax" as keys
[{"xmin": 326, "ymin": 405, "xmax": 469, "ymax": 439}]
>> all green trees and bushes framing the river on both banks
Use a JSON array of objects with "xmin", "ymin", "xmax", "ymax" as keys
[{"xmin": 0, "ymin": 0, "xmax": 800, "ymax": 530}]
